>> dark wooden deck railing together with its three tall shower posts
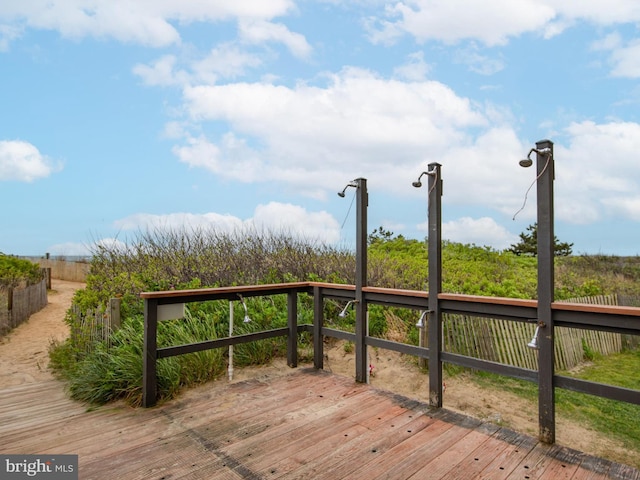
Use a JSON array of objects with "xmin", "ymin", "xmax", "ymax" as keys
[{"xmin": 141, "ymin": 149, "xmax": 640, "ymax": 443}]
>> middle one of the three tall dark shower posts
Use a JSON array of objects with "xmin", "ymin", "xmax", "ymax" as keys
[{"xmin": 427, "ymin": 163, "xmax": 442, "ymax": 408}]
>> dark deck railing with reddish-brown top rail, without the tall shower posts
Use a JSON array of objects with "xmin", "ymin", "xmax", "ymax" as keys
[{"xmin": 141, "ymin": 282, "xmax": 640, "ymax": 446}]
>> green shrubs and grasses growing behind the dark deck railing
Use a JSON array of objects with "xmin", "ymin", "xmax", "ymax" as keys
[{"xmin": 46, "ymin": 228, "xmax": 640, "ymax": 460}]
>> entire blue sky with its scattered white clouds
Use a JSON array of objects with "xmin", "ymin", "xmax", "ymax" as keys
[{"xmin": 0, "ymin": 0, "xmax": 640, "ymax": 255}]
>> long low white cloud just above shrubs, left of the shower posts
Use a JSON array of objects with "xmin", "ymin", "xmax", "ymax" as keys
[{"xmin": 115, "ymin": 202, "xmax": 340, "ymax": 243}]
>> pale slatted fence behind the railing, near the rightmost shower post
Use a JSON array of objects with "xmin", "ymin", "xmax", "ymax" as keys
[{"xmin": 442, "ymin": 294, "xmax": 629, "ymax": 371}]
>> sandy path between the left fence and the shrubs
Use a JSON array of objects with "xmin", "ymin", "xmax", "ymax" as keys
[{"xmin": 0, "ymin": 279, "xmax": 84, "ymax": 388}]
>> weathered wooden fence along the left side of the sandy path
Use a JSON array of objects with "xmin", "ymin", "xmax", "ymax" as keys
[{"xmin": 0, "ymin": 278, "xmax": 48, "ymax": 337}]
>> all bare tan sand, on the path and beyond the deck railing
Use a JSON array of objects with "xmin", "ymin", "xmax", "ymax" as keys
[{"xmin": 0, "ymin": 279, "xmax": 640, "ymax": 468}]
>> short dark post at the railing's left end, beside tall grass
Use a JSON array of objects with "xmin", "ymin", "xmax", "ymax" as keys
[{"xmin": 142, "ymin": 298, "xmax": 158, "ymax": 407}]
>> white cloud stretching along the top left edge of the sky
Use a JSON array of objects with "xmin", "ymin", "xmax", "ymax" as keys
[{"xmin": 0, "ymin": 0, "xmax": 295, "ymax": 47}]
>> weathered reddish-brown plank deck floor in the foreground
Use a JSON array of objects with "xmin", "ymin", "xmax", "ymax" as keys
[{"xmin": 0, "ymin": 369, "xmax": 640, "ymax": 480}]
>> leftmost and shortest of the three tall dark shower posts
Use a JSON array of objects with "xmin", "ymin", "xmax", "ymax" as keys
[{"xmin": 354, "ymin": 178, "xmax": 369, "ymax": 383}]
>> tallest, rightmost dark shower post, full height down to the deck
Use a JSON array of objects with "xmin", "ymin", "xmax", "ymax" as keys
[{"xmin": 536, "ymin": 140, "xmax": 556, "ymax": 443}]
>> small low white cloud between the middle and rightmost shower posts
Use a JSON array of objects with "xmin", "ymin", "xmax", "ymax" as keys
[{"xmin": 419, "ymin": 217, "xmax": 518, "ymax": 250}]
